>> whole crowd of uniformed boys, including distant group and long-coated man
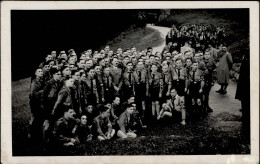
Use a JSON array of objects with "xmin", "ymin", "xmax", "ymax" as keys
[{"xmin": 29, "ymin": 25, "xmax": 232, "ymax": 146}]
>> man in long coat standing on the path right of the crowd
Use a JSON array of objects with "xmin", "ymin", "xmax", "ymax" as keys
[{"xmin": 216, "ymin": 47, "xmax": 233, "ymax": 94}]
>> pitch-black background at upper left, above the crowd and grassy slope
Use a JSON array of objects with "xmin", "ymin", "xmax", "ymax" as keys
[{"xmin": 11, "ymin": 10, "xmax": 158, "ymax": 80}]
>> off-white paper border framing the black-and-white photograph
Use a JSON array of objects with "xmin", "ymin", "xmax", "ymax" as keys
[{"xmin": 1, "ymin": 1, "xmax": 259, "ymax": 164}]
